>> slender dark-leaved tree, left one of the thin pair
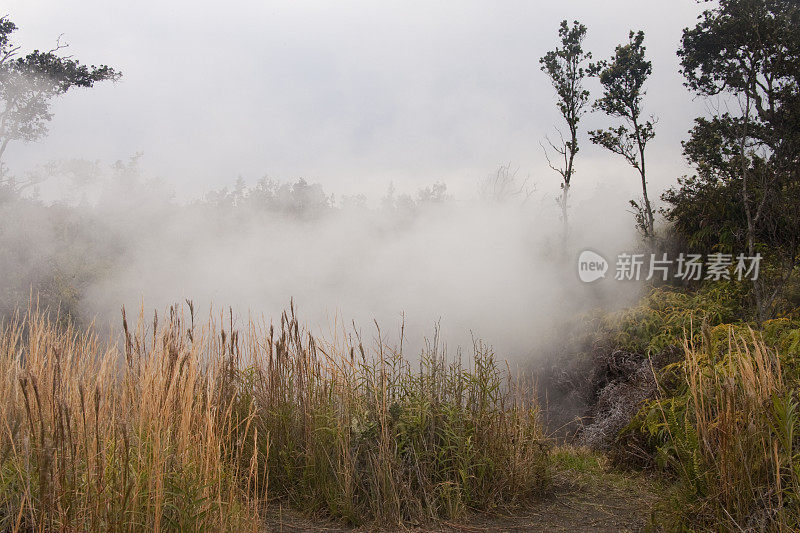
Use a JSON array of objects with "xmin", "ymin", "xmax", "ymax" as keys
[{"xmin": 539, "ymin": 20, "xmax": 592, "ymax": 240}]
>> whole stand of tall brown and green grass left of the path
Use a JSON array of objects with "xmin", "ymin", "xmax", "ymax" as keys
[{"xmin": 0, "ymin": 304, "xmax": 547, "ymax": 531}]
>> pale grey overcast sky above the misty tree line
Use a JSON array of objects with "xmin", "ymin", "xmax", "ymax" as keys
[{"xmin": 4, "ymin": 0, "xmax": 703, "ymax": 202}]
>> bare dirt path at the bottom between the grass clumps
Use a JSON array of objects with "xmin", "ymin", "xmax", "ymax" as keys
[{"xmin": 260, "ymin": 449, "xmax": 664, "ymax": 533}]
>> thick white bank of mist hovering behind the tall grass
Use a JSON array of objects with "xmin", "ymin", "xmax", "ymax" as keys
[{"xmin": 0, "ymin": 159, "xmax": 637, "ymax": 361}]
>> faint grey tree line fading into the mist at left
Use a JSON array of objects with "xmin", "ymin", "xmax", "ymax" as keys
[{"xmin": 0, "ymin": 150, "xmax": 478, "ymax": 321}]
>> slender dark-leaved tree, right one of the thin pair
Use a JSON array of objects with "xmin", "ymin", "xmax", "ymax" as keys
[{"xmin": 589, "ymin": 31, "xmax": 656, "ymax": 243}]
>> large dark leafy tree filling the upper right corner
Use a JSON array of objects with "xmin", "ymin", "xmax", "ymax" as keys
[{"xmin": 669, "ymin": 0, "xmax": 800, "ymax": 320}]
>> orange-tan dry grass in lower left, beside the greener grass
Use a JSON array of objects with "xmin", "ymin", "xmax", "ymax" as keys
[{"xmin": 0, "ymin": 306, "xmax": 260, "ymax": 531}]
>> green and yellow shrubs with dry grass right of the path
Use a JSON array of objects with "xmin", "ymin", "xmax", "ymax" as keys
[{"xmin": 573, "ymin": 284, "xmax": 800, "ymax": 531}]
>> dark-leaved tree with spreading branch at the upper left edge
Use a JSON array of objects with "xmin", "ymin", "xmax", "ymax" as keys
[{"xmin": 0, "ymin": 17, "xmax": 121, "ymax": 192}]
